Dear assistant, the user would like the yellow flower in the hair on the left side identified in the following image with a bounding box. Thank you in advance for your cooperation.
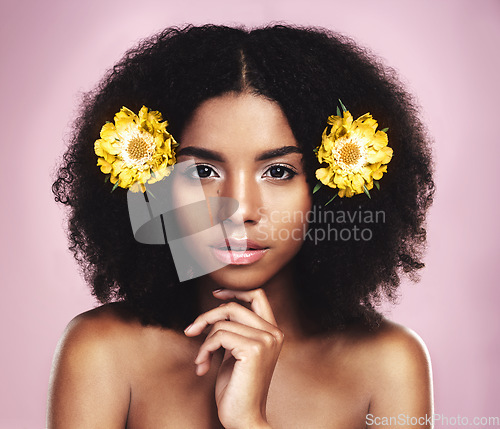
[94,106,178,192]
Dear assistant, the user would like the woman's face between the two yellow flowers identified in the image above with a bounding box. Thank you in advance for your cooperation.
[172,93,312,289]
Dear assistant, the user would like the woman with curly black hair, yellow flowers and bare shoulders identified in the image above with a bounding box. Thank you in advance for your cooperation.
[48,26,433,429]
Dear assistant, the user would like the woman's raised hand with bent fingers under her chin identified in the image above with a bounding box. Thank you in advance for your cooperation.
[185,289,283,429]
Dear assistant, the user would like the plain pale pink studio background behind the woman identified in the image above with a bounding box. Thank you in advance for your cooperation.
[0,0,500,429]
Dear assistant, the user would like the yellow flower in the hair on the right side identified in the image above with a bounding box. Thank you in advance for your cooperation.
[316,111,392,197]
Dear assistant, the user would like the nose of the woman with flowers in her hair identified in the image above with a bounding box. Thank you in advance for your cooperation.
[217,171,262,225]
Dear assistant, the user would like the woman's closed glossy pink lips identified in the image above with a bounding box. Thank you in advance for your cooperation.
[211,238,269,265]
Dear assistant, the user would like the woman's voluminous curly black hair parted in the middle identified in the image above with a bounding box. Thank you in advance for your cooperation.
[53,25,434,330]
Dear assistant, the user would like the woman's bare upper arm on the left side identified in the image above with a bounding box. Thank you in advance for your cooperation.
[47,314,130,429]
